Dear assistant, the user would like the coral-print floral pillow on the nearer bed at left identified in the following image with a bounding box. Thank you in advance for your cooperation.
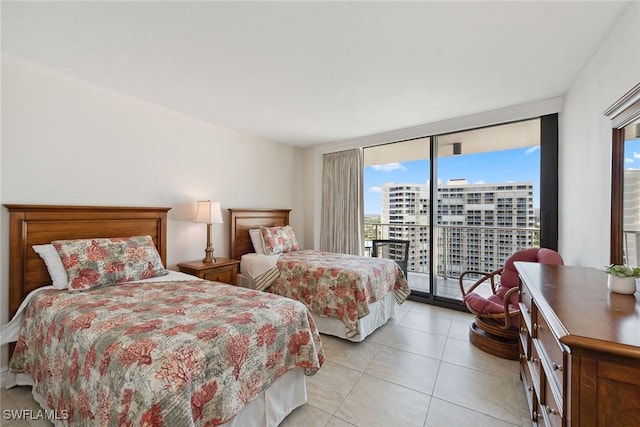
[51,236,169,292]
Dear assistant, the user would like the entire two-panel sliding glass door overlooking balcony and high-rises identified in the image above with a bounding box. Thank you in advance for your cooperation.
[364,116,557,307]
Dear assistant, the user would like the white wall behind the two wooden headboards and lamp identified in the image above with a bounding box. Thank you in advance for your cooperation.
[0,55,305,372]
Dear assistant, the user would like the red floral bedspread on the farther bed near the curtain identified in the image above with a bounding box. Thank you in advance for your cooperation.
[269,250,411,338]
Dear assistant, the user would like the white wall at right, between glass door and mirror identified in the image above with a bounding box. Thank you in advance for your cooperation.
[558,2,640,268]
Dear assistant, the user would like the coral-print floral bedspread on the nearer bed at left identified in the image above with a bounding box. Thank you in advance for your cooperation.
[10,280,324,426]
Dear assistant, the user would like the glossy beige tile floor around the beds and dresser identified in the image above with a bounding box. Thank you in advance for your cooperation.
[0,301,531,427]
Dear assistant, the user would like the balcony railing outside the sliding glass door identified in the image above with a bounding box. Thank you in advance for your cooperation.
[365,223,540,299]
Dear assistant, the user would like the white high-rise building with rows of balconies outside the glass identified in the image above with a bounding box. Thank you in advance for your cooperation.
[381,179,537,277]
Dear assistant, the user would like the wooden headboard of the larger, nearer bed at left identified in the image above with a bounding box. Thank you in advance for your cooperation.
[4,205,171,317]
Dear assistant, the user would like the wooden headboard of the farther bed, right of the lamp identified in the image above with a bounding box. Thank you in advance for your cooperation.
[229,209,291,259]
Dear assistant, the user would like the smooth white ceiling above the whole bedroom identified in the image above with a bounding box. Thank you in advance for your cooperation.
[1,1,630,146]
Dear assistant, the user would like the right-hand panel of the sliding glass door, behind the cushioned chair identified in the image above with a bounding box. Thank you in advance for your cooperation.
[433,119,540,300]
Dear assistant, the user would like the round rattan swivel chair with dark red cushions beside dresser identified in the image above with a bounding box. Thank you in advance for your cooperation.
[459,248,563,360]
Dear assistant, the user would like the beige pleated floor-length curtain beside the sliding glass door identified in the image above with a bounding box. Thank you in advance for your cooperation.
[320,148,364,255]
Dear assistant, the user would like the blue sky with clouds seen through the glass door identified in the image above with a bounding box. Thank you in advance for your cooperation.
[364,146,540,214]
